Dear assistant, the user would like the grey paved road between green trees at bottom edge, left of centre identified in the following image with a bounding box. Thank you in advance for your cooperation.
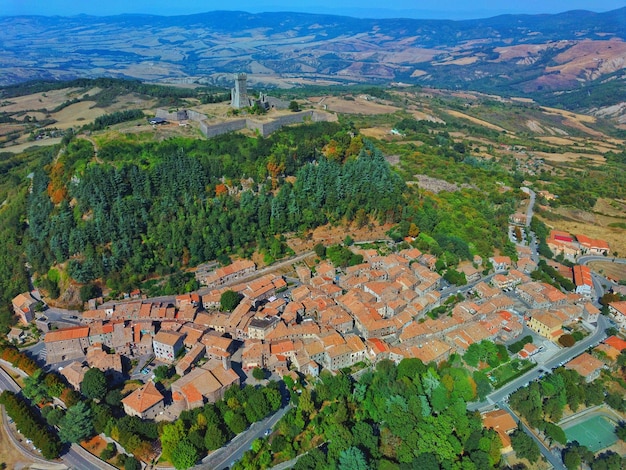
[194,405,291,470]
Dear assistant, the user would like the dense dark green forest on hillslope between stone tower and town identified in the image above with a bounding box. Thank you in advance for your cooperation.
[27,124,404,290]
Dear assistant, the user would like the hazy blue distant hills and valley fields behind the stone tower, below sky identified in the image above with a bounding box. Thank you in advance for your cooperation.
[0,8,626,94]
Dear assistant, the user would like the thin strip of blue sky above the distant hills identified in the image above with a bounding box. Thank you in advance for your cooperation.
[0,0,626,19]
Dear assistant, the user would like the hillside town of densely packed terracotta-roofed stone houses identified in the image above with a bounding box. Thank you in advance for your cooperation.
[9,217,626,430]
